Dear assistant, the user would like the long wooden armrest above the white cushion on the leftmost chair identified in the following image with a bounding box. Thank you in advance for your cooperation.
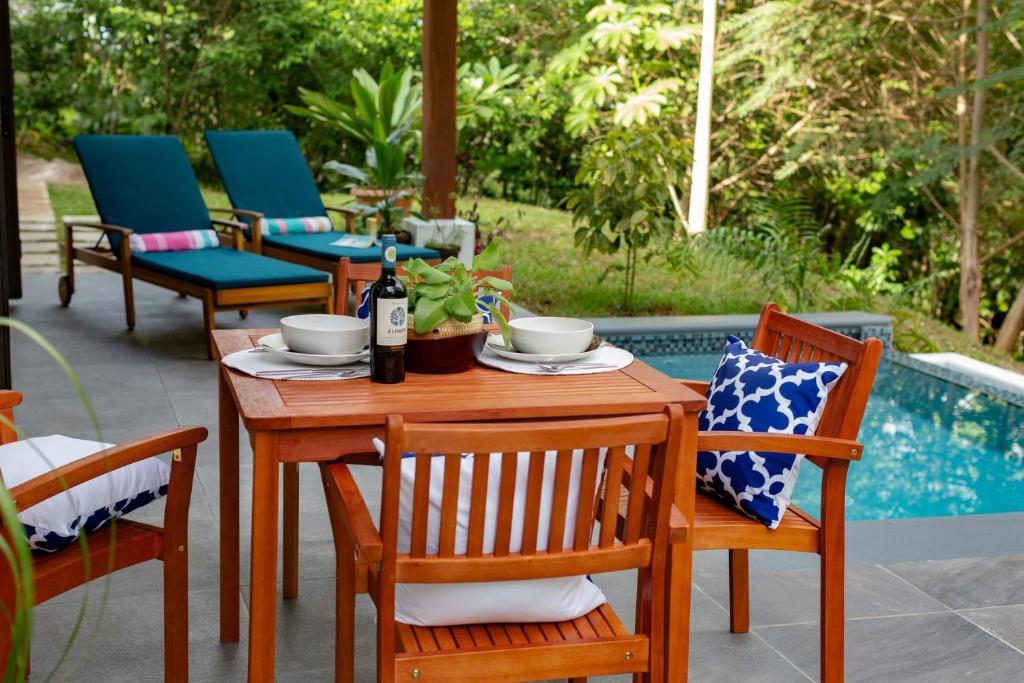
[10,427,207,510]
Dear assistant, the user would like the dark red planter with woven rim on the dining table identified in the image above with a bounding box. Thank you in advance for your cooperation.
[406,314,487,375]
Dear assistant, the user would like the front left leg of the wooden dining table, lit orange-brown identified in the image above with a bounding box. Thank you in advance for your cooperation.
[249,432,280,682]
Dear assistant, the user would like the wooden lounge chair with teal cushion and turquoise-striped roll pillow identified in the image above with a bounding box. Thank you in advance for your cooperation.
[204,130,440,286]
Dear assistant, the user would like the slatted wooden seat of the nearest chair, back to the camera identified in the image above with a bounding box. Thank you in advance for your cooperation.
[395,604,649,681]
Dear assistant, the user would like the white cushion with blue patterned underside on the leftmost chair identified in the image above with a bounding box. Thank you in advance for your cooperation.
[0,434,171,553]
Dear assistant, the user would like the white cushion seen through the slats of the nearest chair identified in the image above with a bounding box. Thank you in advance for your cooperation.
[374,439,607,626]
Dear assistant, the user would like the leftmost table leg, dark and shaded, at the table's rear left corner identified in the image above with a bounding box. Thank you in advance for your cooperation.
[217,370,240,643]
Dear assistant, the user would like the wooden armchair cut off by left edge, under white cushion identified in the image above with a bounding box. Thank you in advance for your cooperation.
[0,391,207,681]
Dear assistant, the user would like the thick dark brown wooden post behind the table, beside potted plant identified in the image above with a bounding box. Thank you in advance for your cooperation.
[423,0,459,218]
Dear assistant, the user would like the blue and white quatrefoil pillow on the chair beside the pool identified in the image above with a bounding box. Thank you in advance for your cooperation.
[697,337,847,528]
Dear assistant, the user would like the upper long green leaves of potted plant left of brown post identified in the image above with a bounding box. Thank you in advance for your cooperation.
[286,61,423,151]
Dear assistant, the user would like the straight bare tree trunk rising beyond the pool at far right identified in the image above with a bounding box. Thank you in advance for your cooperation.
[959,0,988,339]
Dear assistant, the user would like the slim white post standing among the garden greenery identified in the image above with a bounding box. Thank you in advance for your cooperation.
[687,0,716,234]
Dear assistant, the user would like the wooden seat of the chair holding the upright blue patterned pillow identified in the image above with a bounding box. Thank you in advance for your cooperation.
[693,493,820,553]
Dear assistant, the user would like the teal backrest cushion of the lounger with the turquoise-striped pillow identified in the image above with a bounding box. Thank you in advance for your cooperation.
[204,130,327,218]
